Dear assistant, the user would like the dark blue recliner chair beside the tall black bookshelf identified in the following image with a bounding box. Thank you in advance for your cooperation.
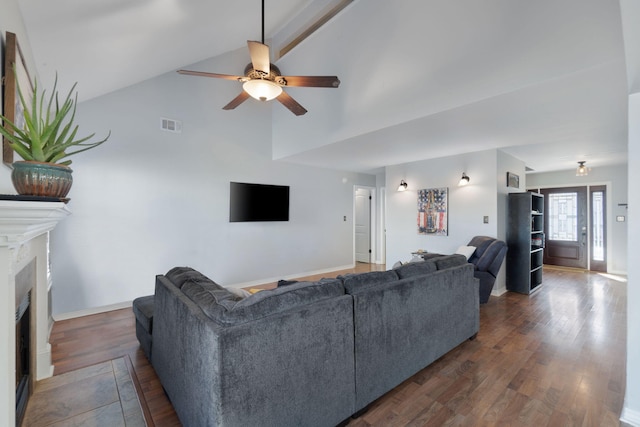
[468,236,507,304]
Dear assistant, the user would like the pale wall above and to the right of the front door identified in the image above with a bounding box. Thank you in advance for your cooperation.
[527,162,628,274]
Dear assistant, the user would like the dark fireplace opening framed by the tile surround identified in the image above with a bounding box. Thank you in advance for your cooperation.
[16,291,31,426]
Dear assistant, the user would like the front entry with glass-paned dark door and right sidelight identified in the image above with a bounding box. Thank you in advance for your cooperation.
[540,185,607,271]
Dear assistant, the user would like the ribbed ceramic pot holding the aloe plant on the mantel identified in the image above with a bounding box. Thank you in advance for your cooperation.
[11,161,73,198]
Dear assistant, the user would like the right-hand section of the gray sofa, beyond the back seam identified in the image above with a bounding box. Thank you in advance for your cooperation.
[344,255,480,411]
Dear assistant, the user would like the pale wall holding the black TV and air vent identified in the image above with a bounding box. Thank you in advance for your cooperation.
[46,49,375,314]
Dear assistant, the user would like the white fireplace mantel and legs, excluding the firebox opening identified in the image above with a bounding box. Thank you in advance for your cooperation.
[0,200,71,426]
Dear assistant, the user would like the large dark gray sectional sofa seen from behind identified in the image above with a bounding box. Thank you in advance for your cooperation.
[134,255,479,427]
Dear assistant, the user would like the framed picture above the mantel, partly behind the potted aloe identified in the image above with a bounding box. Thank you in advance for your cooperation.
[2,31,33,166]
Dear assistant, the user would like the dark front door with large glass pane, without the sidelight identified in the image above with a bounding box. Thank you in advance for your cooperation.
[541,187,589,269]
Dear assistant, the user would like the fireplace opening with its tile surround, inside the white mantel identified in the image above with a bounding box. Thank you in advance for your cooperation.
[16,259,36,426]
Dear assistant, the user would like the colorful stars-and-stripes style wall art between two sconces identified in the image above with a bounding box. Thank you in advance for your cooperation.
[418,188,449,236]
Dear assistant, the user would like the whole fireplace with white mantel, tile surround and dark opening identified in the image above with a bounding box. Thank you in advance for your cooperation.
[0,198,71,427]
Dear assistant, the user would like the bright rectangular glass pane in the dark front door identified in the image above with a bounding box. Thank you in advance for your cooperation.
[547,193,578,242]
